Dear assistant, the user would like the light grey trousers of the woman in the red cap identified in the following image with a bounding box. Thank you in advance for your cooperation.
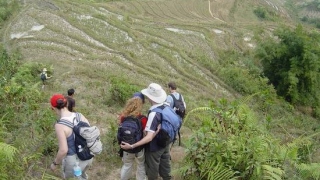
[61,154,93,179]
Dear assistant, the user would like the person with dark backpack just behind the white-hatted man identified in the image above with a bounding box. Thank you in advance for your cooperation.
[166,82,187,119]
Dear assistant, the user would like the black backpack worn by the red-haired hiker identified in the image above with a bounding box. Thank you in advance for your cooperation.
[117,116,143,153]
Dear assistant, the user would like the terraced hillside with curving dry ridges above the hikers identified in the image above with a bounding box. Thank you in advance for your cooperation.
[5,0,282,104]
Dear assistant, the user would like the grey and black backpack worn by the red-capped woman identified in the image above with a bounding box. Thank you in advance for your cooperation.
[57,113,102,161]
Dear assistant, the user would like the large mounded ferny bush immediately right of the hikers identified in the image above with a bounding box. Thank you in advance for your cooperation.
[181,100,284,180]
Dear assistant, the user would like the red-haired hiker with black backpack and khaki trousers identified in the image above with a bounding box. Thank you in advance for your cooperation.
[117,92,147,180]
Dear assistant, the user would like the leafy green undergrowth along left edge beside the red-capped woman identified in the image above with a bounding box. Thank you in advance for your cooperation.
[0,48,50,179]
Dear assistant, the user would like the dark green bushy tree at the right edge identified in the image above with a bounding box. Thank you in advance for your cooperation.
[257,25,320,106]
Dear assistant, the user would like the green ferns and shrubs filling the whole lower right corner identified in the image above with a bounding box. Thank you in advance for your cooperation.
[180,97,320,180]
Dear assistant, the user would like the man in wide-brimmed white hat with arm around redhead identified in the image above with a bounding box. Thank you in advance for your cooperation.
[120,83,171,180]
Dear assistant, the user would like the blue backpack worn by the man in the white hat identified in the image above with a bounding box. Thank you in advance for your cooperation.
[151,105,182,147]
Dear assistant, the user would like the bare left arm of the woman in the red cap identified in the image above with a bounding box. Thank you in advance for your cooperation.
[51,124,68,170]
